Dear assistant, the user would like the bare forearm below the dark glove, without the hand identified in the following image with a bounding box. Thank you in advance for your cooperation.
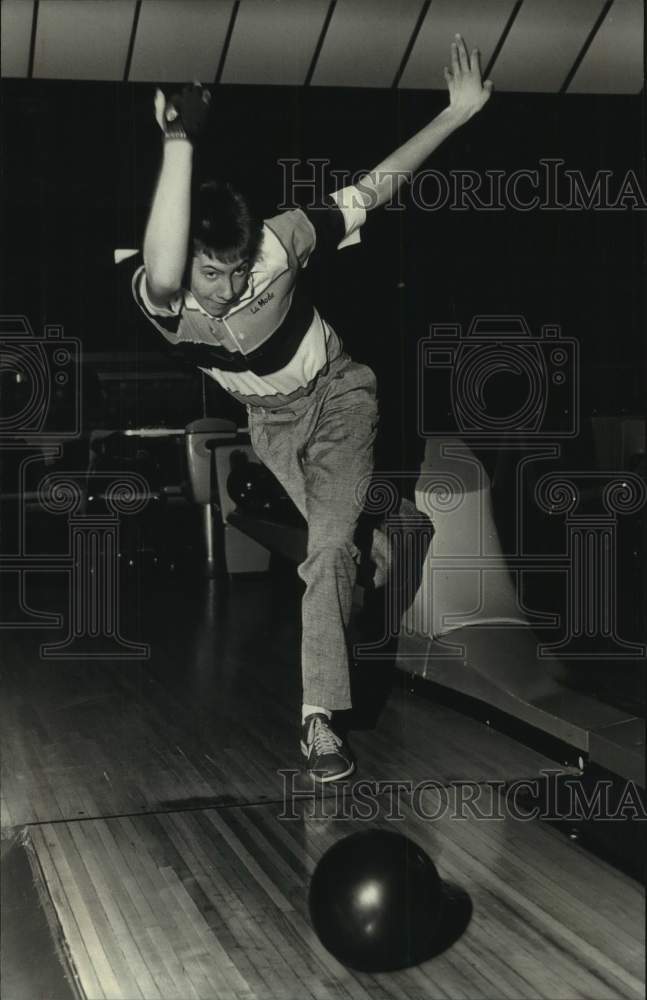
[144,139,193,305]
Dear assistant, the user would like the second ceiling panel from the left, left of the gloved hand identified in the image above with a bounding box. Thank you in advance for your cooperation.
[34,0,135,80]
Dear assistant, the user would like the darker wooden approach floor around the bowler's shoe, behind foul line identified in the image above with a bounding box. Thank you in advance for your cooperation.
[0,579,568,830]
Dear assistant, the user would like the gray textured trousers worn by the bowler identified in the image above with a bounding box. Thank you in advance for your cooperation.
[248,354,387,710]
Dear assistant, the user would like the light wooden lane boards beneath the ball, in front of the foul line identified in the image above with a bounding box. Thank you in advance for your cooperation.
[30,792,644,1000]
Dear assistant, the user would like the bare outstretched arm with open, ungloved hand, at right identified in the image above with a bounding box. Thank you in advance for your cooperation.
[356,35,493,209]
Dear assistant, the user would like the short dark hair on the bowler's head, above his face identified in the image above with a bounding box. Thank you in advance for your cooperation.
[191,181,263,263]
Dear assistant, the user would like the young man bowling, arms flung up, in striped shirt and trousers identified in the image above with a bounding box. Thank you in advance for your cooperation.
[133,35,492,781]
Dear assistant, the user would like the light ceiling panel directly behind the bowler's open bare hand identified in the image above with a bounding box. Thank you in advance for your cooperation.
[400,0,514,90]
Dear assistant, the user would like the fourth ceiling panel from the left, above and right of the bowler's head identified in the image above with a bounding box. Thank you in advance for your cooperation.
[222,0,329,86]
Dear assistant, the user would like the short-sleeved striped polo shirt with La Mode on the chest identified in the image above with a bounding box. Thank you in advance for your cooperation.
[132,187,366,409]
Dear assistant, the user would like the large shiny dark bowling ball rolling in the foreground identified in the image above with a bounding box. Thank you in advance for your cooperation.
[308,829,471,972]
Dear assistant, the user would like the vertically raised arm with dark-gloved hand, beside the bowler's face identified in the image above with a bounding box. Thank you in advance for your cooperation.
[143,85,209,305]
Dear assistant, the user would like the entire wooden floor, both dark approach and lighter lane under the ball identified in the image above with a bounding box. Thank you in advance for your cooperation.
[5,579,644,1000]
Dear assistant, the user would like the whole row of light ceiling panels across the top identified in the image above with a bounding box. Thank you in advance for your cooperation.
[0,0,644,94]
